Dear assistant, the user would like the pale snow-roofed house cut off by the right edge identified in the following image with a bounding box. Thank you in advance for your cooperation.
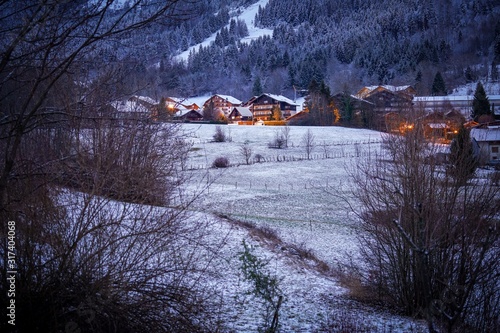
[470,121,500,165]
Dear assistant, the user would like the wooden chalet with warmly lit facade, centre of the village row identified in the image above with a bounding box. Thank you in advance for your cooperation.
[247,93,298,120]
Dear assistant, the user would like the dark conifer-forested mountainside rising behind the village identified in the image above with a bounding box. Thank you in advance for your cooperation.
[99,0,500,99]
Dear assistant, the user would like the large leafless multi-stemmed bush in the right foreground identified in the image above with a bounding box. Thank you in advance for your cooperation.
[352,122,500,332]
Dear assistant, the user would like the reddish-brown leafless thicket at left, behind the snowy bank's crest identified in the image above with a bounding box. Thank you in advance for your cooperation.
[58,121,189,205]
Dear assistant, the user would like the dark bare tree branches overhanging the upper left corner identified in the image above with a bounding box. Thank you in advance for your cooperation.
[0,0,191,207]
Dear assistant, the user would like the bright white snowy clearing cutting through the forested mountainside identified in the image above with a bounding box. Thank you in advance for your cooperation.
[176,0,273,61]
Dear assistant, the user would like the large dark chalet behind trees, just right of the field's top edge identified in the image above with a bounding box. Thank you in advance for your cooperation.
[355,85,416,131]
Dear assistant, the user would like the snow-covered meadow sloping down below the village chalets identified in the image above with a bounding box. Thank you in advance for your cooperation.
[178,124,424,332]
